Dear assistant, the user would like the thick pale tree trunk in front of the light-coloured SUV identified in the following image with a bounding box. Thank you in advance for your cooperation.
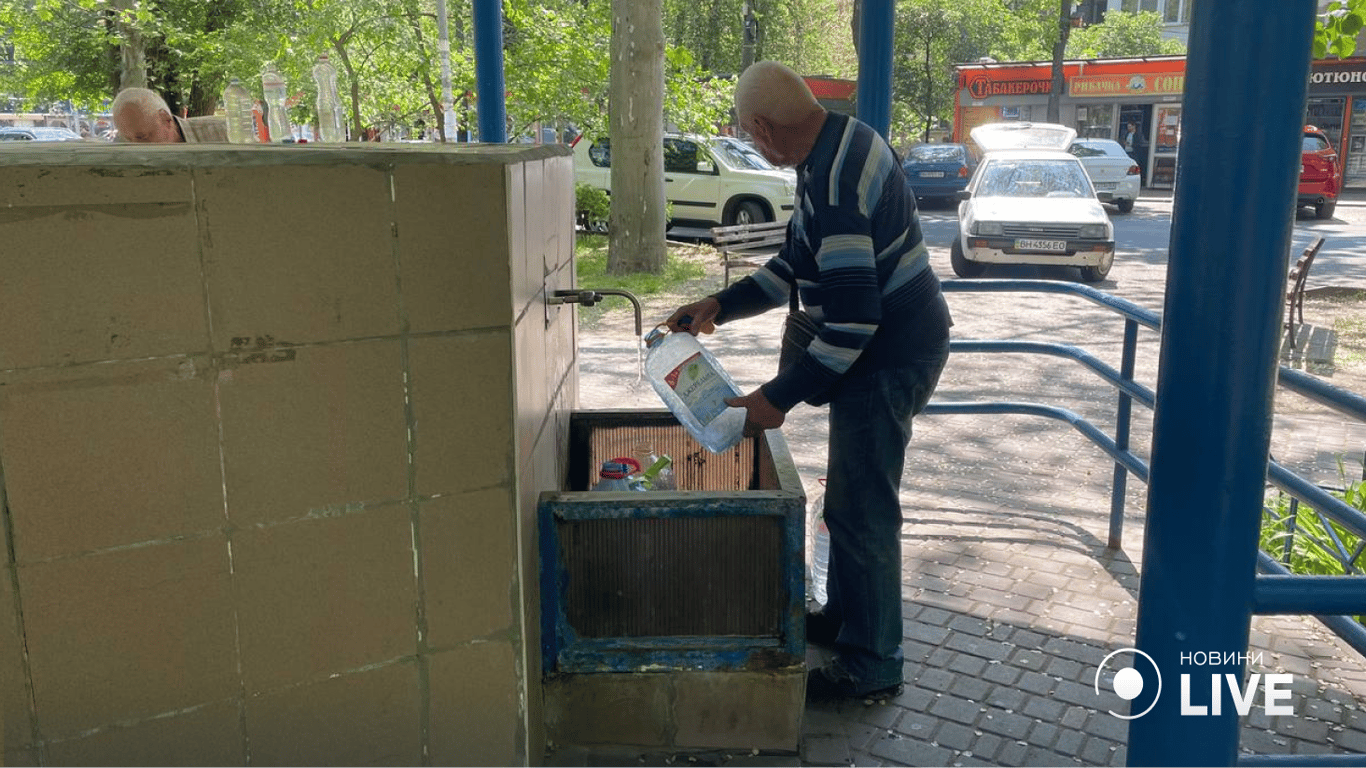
[607,0,665,275]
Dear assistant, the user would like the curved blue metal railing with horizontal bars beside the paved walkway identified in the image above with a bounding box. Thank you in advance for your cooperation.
[925,280,1366,767]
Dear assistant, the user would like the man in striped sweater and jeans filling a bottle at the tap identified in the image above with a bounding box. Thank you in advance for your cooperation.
[668,61,952,701]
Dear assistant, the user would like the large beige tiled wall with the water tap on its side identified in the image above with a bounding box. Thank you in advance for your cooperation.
[0,146,576,765]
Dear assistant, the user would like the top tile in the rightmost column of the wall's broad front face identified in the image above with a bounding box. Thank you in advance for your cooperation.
[393,164,512,333]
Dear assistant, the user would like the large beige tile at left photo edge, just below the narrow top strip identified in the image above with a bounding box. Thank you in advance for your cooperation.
[0,194,208,369]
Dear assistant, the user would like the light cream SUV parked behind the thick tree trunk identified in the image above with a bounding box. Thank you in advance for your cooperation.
[574,134,796,227]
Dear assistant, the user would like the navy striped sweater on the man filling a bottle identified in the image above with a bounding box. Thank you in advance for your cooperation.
[716,112,952,411]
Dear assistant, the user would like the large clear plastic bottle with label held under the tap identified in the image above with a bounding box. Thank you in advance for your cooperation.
[645,328,746,454]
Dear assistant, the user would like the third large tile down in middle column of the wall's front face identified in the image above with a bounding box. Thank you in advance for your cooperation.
[232,504,417,694]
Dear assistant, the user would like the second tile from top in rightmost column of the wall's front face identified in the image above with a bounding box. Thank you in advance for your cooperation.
[408,329,515,495]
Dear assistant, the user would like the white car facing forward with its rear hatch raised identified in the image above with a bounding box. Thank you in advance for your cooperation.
[949,123,1115,283]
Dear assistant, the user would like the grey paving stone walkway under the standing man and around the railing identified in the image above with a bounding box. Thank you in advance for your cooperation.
[556,217,1366,768]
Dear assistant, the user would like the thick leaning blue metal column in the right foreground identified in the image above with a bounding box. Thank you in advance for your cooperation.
[1128,0,1314,767]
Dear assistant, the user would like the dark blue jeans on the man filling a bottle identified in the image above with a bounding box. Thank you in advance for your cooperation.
[824,340,948,690]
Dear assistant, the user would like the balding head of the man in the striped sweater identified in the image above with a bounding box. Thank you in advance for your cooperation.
[735,61,825,165]
